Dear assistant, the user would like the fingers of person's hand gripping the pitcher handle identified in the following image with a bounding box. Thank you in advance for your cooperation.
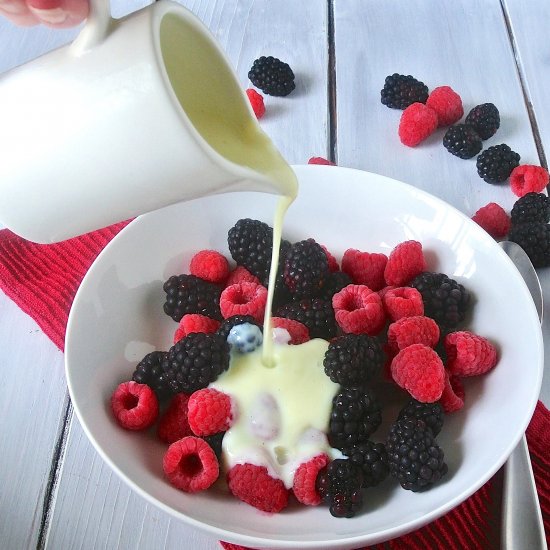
[0,0,89,28]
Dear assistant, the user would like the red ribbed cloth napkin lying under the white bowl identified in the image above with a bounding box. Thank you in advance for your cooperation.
[0,226,550,550]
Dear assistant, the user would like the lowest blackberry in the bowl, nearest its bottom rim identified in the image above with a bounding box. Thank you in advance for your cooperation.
[316,458,363,518]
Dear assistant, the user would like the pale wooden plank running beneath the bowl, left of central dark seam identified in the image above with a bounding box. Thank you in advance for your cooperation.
[47,0,327,550]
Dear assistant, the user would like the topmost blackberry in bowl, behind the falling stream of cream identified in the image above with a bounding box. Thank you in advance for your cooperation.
[227,218,290,286]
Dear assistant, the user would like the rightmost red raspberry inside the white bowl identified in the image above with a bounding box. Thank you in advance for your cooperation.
[444,330,498,376]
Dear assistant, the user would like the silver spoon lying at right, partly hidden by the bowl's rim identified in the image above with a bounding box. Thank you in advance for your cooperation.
[499,241,547,550]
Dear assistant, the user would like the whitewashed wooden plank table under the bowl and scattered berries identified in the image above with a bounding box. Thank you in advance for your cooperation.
[0,0,550,550]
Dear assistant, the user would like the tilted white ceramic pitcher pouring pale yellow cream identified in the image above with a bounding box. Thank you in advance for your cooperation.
[0,0,296,243]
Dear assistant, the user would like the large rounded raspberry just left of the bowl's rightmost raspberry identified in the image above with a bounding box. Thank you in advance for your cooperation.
[390,344,445,403]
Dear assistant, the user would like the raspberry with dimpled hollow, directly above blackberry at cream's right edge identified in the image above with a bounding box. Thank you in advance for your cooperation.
[332,285,386,336]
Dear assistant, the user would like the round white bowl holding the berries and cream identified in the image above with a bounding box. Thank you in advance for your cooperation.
[66,166,543,549]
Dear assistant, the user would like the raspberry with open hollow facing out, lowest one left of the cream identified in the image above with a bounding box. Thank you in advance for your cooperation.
[162,436,220,493]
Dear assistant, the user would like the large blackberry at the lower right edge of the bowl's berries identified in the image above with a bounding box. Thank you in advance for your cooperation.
[386,418,447,492]
